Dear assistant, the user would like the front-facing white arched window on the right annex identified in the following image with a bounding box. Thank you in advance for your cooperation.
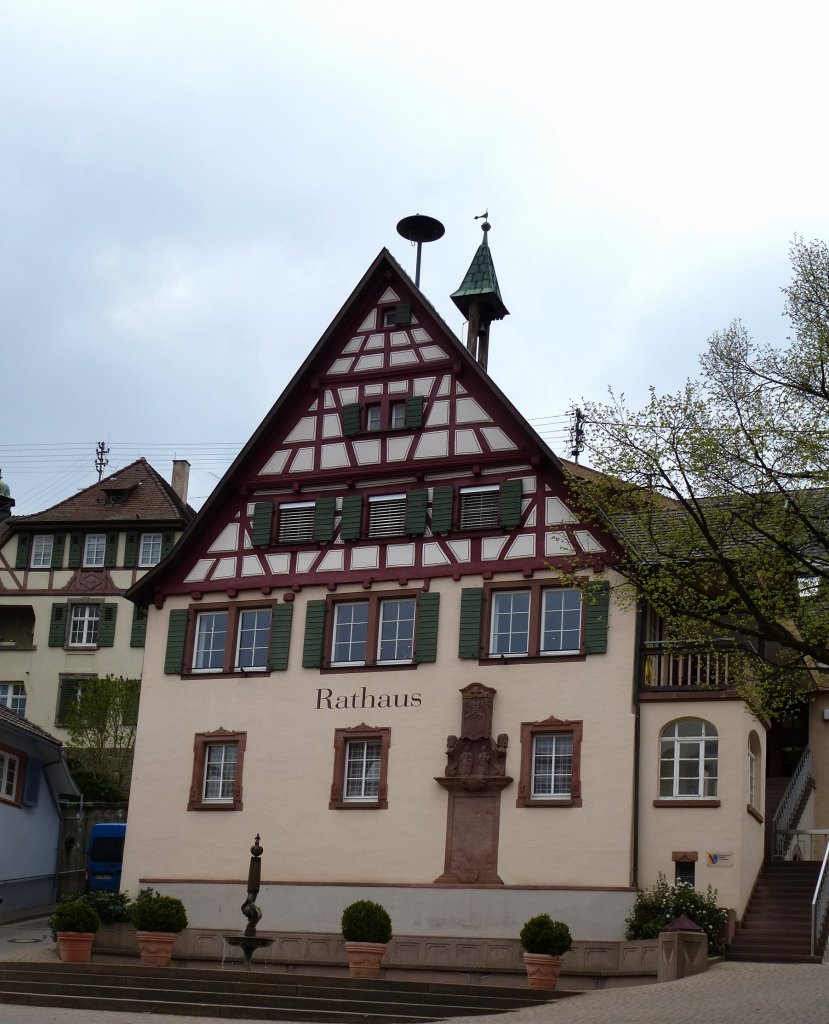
[659,718,717,800]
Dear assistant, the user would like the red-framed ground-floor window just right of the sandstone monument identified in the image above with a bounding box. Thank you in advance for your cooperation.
[516,718,582,807]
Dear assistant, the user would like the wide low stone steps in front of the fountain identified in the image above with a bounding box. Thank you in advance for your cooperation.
[0,962,576,1024]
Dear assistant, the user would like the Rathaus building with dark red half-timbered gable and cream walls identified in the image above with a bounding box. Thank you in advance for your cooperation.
[124,239,766,966]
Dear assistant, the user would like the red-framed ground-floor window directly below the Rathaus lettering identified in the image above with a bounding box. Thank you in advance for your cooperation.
[329,726,391,810]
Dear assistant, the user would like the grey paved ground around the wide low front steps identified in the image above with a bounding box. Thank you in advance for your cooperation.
[0,919,829,1024]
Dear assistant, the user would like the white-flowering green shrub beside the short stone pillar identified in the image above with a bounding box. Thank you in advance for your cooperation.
[624,872,728,956]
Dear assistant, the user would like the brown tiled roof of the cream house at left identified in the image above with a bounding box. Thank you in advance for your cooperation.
[4,459,195,530]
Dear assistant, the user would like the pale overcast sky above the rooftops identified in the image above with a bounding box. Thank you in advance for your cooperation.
[0,0,829,514]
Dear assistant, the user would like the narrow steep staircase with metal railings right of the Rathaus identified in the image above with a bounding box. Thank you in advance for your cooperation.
[726,860,826,964]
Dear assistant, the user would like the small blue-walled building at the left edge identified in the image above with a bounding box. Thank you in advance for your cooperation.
[0,706,78,920]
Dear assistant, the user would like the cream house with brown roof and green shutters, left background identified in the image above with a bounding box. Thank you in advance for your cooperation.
[0,459,194,739]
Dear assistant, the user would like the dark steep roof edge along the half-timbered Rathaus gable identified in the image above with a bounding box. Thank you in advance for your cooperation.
[127,249,562,604]
